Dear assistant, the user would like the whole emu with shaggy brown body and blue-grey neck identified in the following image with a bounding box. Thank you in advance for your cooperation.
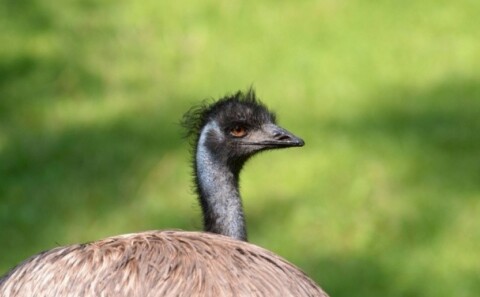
[0,88,328,297]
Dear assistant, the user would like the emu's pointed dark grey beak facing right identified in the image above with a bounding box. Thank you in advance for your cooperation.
[245,124,305,149]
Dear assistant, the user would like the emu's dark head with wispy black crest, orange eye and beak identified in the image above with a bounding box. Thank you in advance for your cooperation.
[183,89,304,171]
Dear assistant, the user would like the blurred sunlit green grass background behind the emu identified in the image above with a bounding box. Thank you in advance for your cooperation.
[0,0,480,297]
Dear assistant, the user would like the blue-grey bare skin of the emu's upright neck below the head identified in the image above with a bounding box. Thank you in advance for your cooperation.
[195,122,247,241]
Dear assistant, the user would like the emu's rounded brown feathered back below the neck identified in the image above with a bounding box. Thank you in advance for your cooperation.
[0,231,326,297]
